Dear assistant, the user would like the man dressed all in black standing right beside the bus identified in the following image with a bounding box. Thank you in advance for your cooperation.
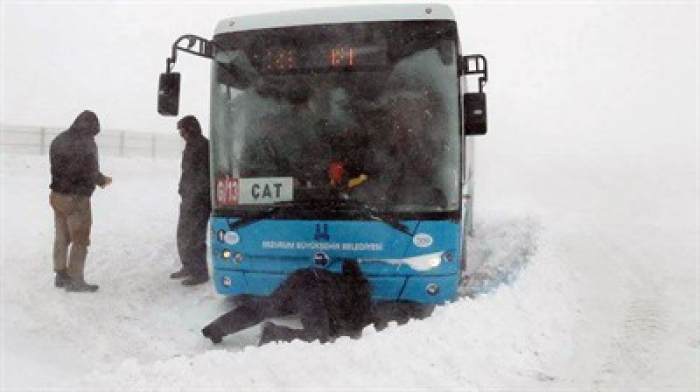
[170,116,211,286]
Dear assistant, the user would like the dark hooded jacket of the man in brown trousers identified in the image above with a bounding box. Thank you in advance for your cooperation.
[49,111,105,196]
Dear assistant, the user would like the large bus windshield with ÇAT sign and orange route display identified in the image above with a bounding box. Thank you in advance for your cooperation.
[211,21,460,214]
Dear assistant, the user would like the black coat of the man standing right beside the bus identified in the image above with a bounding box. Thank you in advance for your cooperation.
[178,135,211,203]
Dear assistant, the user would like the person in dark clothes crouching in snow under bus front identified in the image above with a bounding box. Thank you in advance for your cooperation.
[202,260,372,345]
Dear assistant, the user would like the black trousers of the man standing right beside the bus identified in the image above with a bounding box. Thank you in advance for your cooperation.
[177,198,211,275]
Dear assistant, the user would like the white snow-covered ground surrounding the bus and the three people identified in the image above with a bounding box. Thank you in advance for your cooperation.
[2,140,700,389]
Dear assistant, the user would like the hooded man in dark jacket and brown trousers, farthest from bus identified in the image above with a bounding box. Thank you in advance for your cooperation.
[49,110,112,292]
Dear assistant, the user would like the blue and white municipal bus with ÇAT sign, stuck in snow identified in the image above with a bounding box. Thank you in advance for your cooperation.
[158,4,487,305]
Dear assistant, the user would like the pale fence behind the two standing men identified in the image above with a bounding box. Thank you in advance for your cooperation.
[0,125,184,158]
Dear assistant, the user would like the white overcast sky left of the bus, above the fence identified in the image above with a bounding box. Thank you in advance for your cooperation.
[2,0,492,132]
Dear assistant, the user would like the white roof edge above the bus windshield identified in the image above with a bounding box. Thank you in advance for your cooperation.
[214,4,455,35]
